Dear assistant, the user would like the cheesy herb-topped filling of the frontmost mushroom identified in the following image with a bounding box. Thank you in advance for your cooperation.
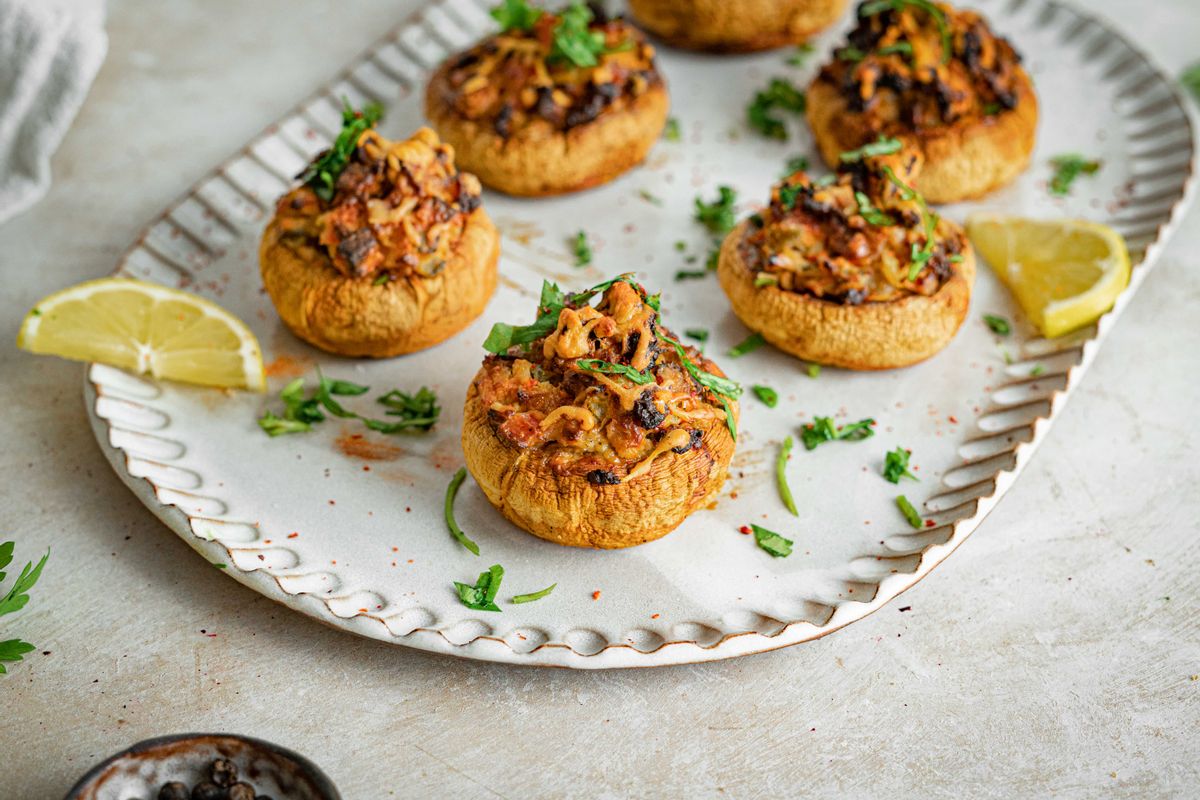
[475,277,740,485]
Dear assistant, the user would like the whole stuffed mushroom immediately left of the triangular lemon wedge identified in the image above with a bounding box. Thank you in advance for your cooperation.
[718,139,974,369]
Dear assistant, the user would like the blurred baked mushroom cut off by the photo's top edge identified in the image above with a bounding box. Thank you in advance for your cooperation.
[629,0,846,52]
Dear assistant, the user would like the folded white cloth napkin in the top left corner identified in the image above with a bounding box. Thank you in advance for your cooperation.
[0,0,108,223]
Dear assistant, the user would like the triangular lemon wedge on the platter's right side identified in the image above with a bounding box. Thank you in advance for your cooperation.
[967,213,1129,337]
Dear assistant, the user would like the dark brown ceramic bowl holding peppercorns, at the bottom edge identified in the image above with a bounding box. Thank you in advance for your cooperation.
[66,733,342,800]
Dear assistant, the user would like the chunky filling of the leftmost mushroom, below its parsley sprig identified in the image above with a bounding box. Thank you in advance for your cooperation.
[276,128,480,283]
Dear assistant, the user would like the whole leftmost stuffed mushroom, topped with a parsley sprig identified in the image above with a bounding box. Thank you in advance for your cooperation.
[259,108,500,357]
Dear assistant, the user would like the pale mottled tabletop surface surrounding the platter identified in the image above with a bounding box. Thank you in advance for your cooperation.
[0,0,1200,799]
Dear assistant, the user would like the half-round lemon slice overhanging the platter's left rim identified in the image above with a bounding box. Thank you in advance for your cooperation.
[17,278,266,391]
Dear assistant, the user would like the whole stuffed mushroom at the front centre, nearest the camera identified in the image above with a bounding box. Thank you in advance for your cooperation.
[462,275,742,548]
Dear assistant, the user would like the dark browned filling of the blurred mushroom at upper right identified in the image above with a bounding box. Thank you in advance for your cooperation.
[820,0,1021,133]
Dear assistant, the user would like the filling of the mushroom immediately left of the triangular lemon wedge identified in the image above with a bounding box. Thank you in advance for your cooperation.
[739,148,966,305]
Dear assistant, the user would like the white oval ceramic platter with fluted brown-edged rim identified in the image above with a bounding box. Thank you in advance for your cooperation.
[86,0,1193,668]
